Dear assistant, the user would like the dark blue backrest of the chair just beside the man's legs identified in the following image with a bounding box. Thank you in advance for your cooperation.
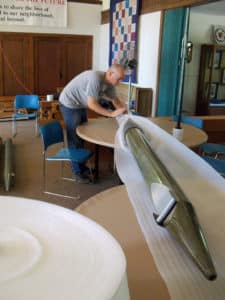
[40,121,64,150]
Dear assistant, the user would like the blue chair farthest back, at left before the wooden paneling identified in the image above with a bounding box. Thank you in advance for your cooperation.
[12,95,40,137]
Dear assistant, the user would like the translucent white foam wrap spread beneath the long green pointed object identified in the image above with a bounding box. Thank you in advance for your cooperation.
[115,116,225,300]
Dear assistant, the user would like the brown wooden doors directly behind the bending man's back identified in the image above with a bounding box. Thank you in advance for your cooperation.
[34,35,92,95]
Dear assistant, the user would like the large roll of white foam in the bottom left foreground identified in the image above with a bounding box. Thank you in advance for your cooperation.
[0,196,129,300]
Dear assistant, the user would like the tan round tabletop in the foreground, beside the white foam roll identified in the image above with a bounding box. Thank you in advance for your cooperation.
[76,185,170,300]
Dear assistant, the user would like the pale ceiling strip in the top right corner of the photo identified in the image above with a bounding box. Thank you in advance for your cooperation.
[191,0,225,16]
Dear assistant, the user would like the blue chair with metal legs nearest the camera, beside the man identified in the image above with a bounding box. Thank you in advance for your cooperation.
[40,121,93,199]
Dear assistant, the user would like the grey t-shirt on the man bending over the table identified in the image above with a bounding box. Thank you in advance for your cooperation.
[59,70,115,108]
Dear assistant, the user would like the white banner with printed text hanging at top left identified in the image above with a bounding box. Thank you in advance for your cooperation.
[0,0,67,27]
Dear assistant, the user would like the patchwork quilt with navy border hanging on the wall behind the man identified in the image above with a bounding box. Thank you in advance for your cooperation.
[109,0,139,83]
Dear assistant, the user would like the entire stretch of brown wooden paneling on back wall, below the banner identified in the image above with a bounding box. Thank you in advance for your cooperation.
[0,32,93,96]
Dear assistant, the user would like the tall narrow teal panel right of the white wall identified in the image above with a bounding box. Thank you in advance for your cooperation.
[157,8,186,116]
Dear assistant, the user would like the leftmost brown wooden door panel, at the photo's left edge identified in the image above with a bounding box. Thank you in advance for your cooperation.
[0,33,34,96]
